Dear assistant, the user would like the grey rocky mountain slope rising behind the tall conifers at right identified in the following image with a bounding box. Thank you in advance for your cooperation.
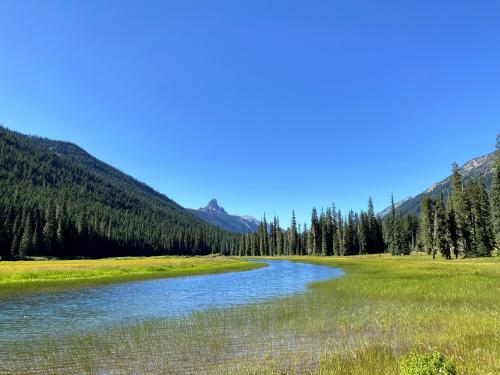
[380,152,495,218]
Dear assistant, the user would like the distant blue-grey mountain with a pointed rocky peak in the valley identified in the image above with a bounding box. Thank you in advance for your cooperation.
[190,199,260,233]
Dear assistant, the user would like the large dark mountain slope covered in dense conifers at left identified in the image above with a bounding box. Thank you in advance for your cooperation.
[0,127,239,259]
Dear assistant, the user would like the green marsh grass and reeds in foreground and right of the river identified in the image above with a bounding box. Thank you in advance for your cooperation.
[0,256,500,375]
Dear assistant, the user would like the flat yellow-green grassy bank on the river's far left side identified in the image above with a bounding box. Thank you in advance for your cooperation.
[0,256,264,297]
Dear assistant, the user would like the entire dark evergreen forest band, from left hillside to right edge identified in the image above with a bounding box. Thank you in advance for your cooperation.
[0,127,500,259]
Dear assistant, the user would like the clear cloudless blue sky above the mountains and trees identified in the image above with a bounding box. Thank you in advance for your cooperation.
[0,0,500,226]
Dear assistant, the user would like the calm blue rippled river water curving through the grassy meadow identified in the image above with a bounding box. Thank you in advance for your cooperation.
[0,260,343,345]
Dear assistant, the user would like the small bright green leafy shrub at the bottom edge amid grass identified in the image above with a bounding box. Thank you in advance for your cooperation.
[399,350,456,375]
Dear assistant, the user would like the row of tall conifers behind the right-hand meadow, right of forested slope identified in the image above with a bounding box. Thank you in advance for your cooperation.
[231,136,500,259]
